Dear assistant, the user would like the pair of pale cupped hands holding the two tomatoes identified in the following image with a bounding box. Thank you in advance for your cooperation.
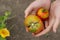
[25,0,60,37]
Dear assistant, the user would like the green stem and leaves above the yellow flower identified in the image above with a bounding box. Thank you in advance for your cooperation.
[0,11,11,29]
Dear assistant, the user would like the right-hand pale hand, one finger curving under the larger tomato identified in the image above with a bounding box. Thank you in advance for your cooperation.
[34,1,60,37]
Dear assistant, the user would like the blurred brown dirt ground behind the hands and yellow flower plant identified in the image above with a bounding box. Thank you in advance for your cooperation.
[0,0,60,40]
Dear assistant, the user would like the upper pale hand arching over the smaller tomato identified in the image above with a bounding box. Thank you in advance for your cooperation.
[25,0,50,17]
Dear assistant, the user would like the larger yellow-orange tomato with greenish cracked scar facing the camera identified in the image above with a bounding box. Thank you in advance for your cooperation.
[24,15,44,33]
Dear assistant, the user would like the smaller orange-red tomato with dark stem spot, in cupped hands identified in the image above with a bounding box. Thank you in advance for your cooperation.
[37,8,49,20]
